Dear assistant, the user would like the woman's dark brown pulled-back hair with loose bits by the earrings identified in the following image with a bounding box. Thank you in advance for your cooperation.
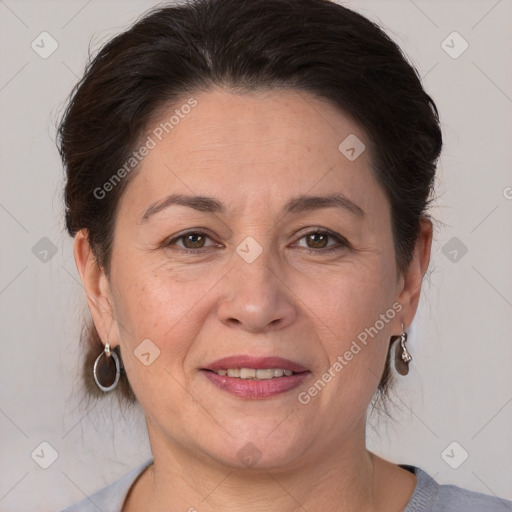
[58,0,442,408]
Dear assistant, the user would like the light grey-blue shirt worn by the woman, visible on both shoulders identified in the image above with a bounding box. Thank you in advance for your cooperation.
[61,460,512,512]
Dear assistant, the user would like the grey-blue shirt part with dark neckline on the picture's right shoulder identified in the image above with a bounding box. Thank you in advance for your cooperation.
[401,465,512,512]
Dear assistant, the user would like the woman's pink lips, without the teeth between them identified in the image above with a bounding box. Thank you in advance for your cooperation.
[201,355,311,399]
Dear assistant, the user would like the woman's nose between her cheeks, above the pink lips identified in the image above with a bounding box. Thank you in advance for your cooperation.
[217,246,298,333]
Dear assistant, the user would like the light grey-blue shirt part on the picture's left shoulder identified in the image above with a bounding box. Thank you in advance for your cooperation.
[61,459,153,512]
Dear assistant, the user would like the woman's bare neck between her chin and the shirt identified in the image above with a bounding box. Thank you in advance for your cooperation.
[134,422,382,512]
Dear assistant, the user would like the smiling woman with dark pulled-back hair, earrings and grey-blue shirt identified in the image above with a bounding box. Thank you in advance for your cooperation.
[59,0,511,512]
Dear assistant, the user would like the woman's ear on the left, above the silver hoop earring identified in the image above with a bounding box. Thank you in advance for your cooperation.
[73,229,119,348]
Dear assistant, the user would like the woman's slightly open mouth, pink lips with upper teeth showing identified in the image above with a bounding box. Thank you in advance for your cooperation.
[201,355,311,399]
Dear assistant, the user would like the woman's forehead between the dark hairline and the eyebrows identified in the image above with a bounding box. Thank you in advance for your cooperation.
[118,89,385,222]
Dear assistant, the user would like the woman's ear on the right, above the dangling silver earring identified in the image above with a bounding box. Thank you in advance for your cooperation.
[396,218,432,335]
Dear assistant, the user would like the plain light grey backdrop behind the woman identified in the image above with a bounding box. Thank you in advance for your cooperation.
[0,0,512,512]
